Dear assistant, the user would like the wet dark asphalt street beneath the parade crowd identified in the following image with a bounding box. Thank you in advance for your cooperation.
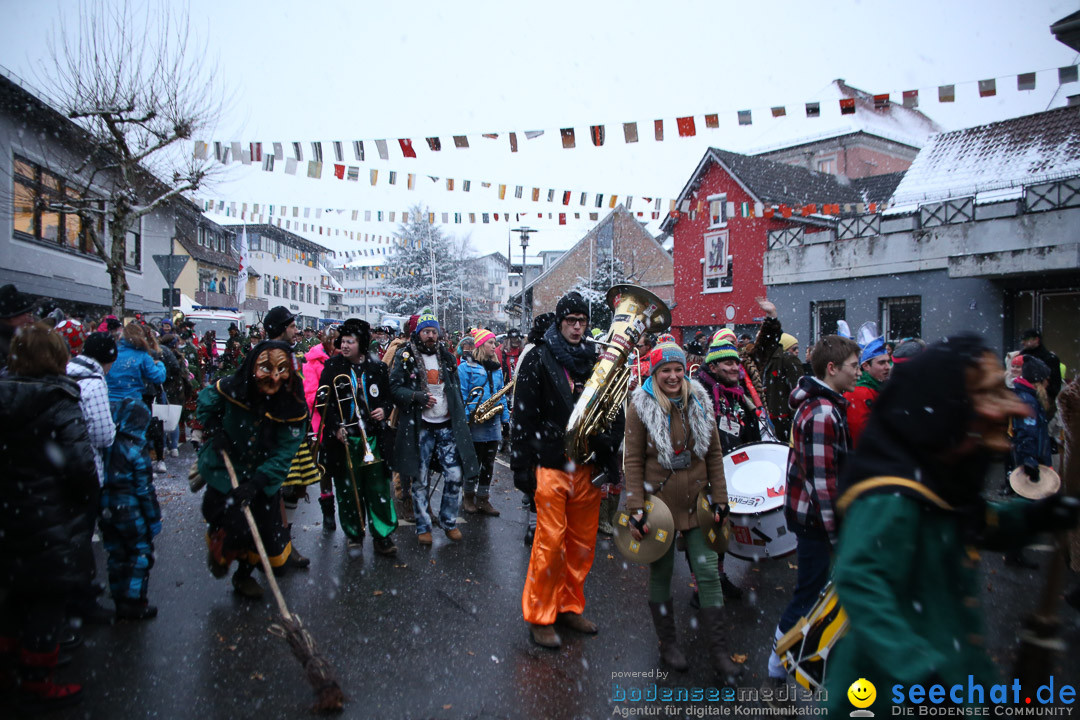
[38,446,1080,720]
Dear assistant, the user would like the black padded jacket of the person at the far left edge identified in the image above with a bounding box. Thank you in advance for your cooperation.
[0,377,98,597]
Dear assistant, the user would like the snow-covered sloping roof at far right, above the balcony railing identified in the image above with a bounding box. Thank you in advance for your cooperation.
[892,107,1080,206]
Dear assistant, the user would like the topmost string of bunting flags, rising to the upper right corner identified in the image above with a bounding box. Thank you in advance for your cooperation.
[193,65,1078,164]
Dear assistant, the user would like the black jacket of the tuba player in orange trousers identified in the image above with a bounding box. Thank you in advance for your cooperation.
[510,343,626,472]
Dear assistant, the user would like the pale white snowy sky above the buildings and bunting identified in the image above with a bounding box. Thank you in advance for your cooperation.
[0,0,1080,258]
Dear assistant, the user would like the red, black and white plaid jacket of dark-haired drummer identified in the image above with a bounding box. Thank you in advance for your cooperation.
[784,377,851,545]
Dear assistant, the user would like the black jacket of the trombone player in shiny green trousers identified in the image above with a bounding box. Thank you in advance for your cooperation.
[319,355,394,467]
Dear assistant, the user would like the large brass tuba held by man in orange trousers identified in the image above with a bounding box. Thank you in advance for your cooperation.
[566,285,672,464]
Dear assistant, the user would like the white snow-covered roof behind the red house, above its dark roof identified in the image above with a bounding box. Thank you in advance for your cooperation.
[750,79,942,154]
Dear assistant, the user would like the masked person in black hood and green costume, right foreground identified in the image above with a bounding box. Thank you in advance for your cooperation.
[825,335,1080,717]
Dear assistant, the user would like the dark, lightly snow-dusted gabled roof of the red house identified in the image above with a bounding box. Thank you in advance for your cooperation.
[660,148,866,232]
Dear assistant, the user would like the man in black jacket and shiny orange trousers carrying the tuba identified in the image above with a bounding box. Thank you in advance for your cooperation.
[510,293,623,649]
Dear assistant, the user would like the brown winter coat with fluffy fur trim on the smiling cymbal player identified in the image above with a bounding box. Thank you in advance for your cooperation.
[623,379,728,530]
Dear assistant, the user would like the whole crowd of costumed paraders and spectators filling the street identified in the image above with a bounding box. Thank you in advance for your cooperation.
[0,278,1080,711]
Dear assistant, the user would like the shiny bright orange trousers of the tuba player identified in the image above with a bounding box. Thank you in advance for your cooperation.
[522,465,600,625]
